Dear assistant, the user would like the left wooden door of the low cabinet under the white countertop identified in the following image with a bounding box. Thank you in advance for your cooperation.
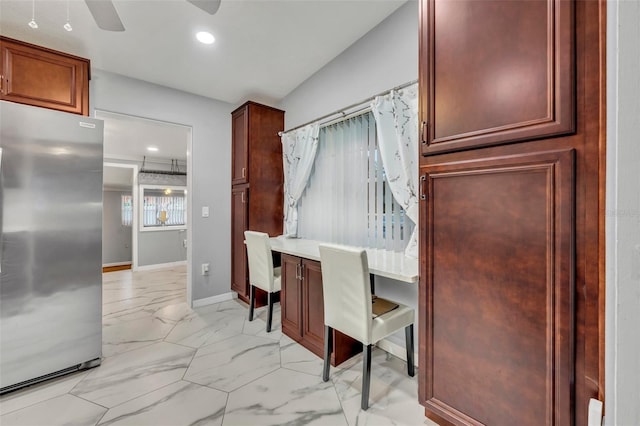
[280,254,302,341]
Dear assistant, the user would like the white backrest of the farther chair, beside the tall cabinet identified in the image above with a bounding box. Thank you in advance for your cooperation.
[244,231,274,293]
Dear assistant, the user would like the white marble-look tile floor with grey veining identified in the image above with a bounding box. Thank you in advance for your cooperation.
[0,267,435,426]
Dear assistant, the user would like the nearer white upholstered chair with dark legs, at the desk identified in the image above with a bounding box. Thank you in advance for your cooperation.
[320,244,415,410]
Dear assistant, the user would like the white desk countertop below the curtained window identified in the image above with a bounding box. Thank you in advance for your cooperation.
[270,236,418,283]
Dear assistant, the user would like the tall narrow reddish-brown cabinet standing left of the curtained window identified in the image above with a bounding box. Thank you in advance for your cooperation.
[231,102,284,306]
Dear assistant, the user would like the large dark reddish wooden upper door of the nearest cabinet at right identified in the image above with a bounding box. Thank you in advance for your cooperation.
[419,0,575,155]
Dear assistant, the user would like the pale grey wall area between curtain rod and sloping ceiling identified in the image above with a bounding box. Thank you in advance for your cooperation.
[279,0,418,129]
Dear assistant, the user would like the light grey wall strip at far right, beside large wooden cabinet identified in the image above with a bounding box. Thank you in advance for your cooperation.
[605,0,640,426]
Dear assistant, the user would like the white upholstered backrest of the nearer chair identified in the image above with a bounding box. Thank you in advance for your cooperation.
[320,244,371,344]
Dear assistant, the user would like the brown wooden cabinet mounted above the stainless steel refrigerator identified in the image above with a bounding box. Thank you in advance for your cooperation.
[0,37,90,115]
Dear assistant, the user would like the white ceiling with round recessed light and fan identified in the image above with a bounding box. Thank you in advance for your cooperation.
[0,0,406,104]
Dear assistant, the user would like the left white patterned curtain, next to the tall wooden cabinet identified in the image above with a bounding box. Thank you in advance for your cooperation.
[282,123,319,237]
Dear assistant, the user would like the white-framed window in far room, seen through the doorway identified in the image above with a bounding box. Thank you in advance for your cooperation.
[140,185,187,231]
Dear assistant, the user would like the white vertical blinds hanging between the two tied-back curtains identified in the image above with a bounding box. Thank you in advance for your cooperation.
[298,112,413,251]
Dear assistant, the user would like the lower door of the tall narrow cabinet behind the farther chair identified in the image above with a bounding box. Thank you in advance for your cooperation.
[231,185,249,299]
